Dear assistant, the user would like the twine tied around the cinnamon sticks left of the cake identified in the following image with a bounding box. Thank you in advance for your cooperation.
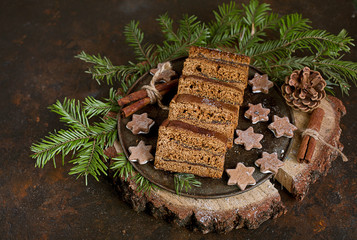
[142,62,172,110]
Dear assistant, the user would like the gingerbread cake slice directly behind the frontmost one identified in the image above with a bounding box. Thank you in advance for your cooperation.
[168,94,239,148]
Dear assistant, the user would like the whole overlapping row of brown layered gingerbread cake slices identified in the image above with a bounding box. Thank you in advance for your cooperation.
[155,46,250,178]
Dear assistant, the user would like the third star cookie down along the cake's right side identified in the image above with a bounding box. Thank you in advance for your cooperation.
[234,127,264,151]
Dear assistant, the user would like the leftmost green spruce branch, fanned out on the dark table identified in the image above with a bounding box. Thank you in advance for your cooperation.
[31,94,117,184]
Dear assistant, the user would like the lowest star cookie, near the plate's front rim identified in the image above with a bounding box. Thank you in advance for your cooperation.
[226,163,256,190]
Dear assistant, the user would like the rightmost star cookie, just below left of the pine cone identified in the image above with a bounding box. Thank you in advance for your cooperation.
[268,115,297,138]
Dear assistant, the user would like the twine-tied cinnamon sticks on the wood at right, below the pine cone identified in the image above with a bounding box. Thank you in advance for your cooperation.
[297,108,325,163]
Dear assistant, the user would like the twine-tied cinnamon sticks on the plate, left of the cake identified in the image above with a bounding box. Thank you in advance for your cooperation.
[118,79,178,118]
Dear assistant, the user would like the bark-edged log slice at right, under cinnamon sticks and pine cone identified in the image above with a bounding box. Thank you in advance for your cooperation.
[276,96,346,200]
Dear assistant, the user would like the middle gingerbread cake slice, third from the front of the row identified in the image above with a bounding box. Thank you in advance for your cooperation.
[177,75,244,106]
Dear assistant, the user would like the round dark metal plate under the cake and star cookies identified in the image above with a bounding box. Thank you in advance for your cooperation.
[118,58,294,198]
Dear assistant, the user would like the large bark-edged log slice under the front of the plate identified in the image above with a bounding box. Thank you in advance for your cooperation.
[106,142,285,233]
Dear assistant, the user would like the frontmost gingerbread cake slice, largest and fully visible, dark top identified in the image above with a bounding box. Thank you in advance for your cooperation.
[154,120,227,178]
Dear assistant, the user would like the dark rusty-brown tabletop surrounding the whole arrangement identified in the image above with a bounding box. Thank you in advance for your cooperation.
[0,0,357,240]
